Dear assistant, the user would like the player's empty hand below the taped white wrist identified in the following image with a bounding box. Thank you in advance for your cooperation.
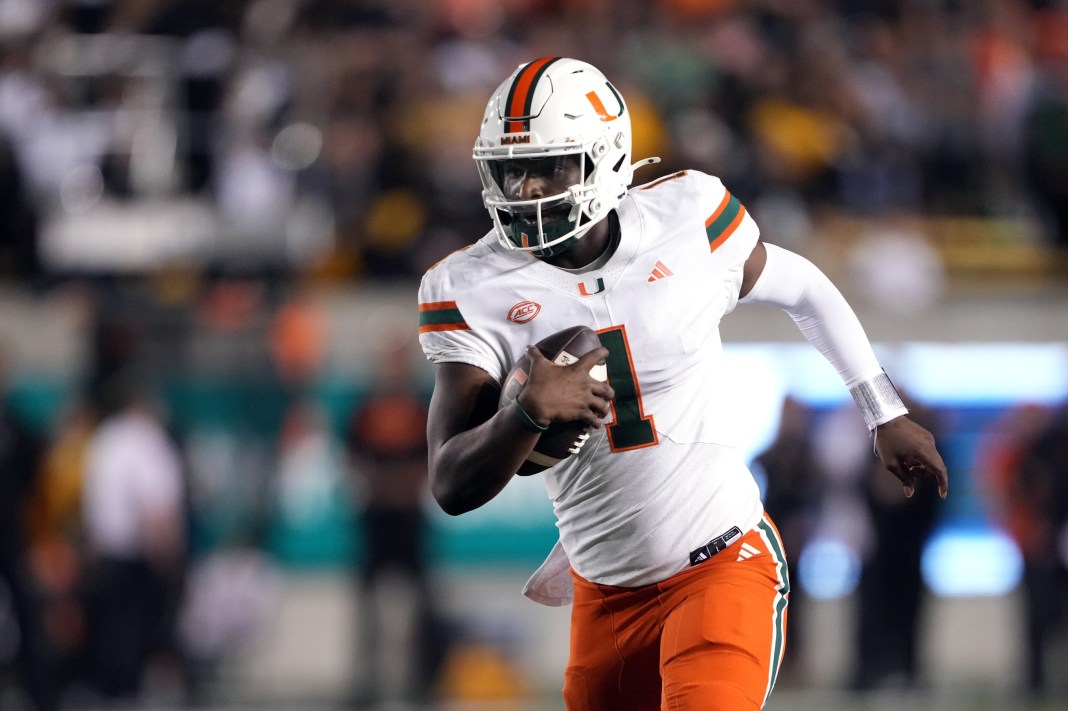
[875,415,949,499]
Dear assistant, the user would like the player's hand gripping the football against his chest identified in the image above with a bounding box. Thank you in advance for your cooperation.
[519,346,615,428]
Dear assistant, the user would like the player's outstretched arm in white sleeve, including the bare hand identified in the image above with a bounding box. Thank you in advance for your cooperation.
[739,241,949,499]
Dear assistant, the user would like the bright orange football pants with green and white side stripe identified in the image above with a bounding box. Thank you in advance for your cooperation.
[564,516,789,711]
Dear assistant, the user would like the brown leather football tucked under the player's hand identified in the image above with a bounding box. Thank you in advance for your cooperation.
[498,326,608,476]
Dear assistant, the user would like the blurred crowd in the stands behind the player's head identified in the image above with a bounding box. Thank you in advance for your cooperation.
[0,0,1068,286]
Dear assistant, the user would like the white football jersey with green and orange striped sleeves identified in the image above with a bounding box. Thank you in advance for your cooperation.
[419,171,763,597]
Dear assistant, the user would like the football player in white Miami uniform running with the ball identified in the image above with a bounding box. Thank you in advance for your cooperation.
[419,58,948,711]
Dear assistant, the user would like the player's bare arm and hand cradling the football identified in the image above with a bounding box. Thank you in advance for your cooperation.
[426,347,612,516]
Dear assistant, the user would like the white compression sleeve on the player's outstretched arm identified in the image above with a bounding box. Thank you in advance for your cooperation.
[739,243,908,428]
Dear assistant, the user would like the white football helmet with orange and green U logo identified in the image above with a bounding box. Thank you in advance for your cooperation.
[474,57,659,256]
